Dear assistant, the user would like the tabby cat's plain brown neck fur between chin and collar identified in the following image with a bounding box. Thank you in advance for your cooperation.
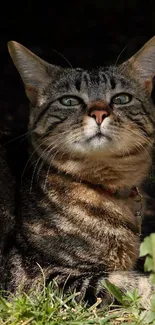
[35,144,151,191]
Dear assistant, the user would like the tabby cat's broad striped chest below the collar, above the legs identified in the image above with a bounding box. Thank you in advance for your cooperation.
[19,172,139,270]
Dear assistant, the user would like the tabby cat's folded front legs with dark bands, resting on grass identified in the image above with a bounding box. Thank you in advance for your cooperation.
[51,271,155,309]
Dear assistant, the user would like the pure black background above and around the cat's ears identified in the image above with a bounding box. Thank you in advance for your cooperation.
[0,0,155,127]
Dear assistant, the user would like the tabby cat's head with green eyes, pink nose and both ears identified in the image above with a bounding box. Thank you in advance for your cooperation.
[8,37,155,163]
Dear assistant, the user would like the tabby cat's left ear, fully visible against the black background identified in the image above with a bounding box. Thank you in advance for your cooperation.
[8,41,58,105]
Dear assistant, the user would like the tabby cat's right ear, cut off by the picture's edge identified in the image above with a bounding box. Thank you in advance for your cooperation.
[128,36,155,92]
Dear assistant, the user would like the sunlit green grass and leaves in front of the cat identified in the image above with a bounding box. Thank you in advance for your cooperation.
[0,234,155,325]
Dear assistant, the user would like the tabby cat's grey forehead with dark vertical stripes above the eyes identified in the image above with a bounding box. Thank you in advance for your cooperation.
[51,67,130,100]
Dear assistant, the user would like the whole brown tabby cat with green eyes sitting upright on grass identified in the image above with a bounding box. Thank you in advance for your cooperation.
[1,37,155,304]
